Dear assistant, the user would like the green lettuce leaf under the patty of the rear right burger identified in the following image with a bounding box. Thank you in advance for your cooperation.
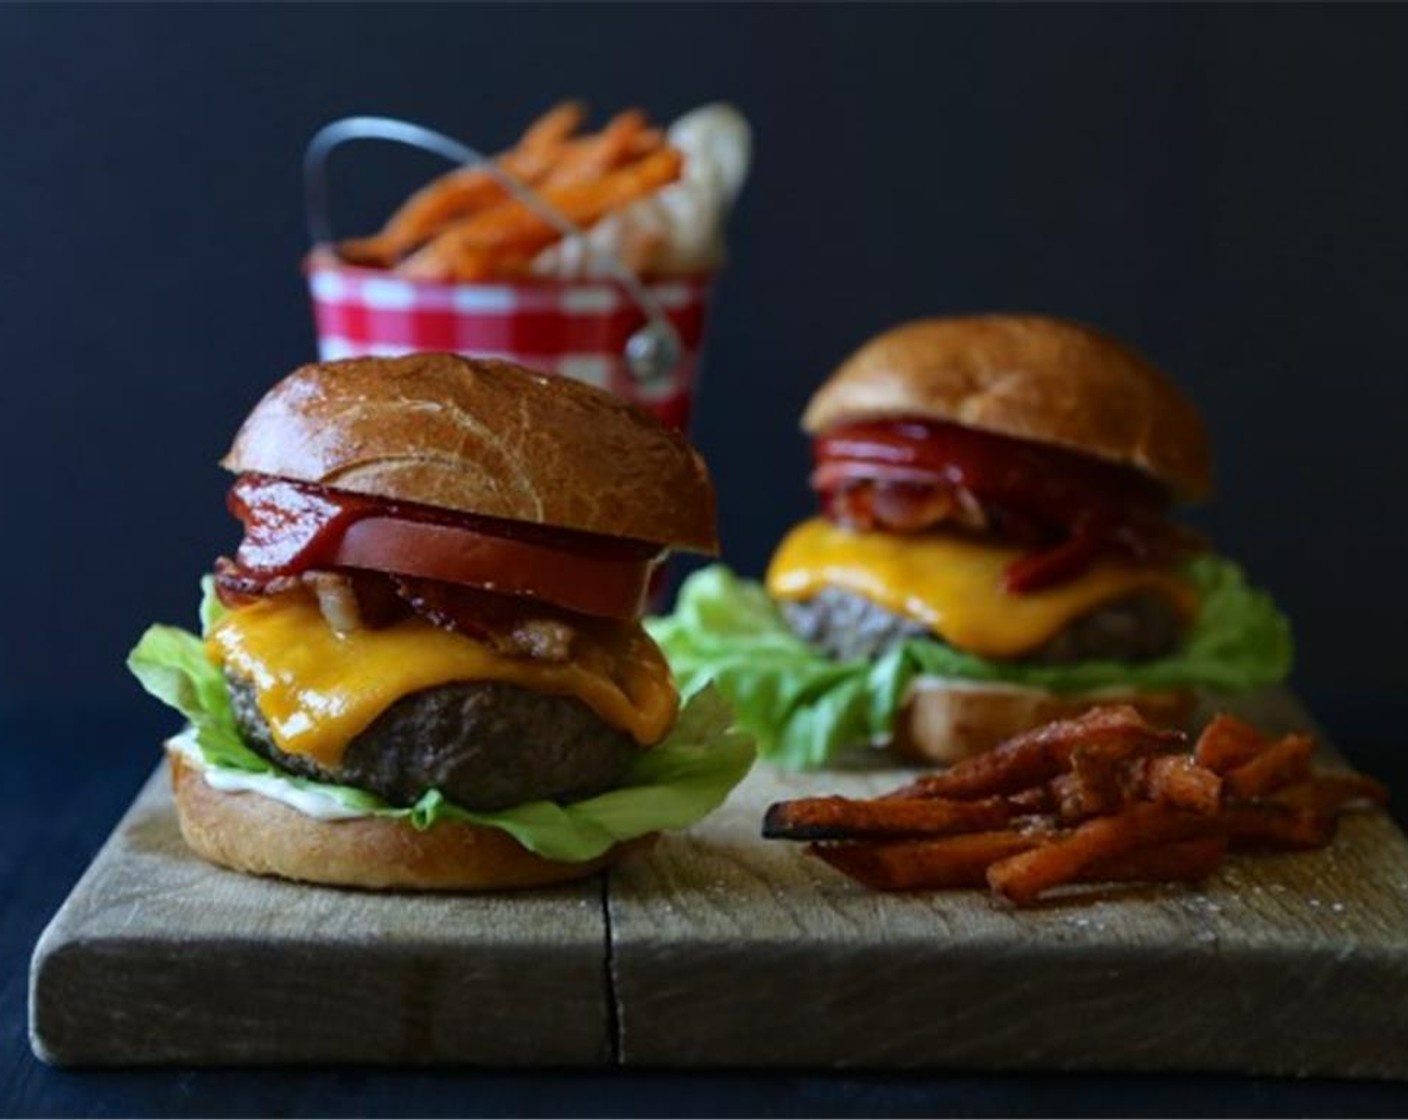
[646,555,1291,769]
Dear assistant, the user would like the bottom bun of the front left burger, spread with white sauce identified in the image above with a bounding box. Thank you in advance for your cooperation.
[166,749,655,890]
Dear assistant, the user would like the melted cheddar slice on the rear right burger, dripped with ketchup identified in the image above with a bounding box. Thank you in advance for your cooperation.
[767,518,1198,658]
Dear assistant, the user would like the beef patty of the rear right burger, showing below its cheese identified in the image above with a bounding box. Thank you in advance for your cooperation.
[779,587,1183,665]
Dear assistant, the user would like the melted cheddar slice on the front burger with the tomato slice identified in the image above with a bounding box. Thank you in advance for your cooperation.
[206,593,679,766]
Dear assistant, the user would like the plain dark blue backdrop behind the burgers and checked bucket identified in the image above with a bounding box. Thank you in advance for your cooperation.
[0,6,1408,718]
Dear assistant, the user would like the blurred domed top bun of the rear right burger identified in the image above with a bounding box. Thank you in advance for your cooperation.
[803,314,1212,499]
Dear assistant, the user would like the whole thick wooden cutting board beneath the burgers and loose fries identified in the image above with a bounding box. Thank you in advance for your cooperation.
[30,693,1408,1078]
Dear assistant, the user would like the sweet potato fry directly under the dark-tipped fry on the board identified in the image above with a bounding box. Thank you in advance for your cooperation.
[808,830,1041,890]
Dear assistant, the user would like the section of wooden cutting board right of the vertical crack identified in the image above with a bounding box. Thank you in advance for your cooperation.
[608,693,1408,1078]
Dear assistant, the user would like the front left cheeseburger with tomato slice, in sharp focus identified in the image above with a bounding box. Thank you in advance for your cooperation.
[130,354,750,889]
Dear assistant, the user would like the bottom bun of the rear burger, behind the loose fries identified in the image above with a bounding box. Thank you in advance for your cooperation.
[894,678,1198,764]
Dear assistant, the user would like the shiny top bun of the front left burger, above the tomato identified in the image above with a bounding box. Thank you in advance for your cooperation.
[221,354,718,554]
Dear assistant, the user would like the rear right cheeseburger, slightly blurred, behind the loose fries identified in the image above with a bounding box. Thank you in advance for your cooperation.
[659,316,1290,765]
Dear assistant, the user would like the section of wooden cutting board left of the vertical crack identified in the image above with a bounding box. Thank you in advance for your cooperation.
[30,764,610,1065]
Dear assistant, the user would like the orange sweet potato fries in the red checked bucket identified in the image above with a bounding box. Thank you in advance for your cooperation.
[338,101,683,280]
